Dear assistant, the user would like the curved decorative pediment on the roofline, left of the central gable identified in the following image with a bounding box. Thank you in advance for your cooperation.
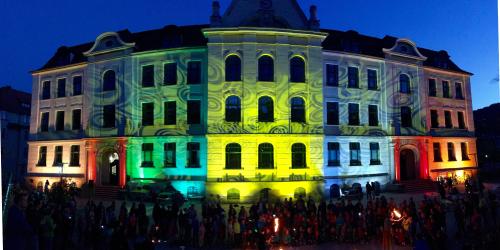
[83,32,135,56]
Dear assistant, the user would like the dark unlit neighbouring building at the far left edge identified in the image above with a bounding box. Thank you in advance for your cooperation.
[0,86,31,187]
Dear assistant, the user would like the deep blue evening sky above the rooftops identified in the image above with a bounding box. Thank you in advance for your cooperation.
[0,0,500,109]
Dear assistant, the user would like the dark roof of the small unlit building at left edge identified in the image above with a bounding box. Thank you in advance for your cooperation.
[0,86,31,115]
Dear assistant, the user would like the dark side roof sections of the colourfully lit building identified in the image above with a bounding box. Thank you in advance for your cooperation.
[39,25,471,75]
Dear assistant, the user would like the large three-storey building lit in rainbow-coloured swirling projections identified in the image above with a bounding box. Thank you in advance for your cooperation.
[28,0,477,200]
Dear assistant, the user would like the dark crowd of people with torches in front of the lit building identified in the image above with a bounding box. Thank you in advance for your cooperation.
[4,177,500,250]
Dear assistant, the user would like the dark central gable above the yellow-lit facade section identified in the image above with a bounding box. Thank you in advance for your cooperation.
[220,0,309,30]
